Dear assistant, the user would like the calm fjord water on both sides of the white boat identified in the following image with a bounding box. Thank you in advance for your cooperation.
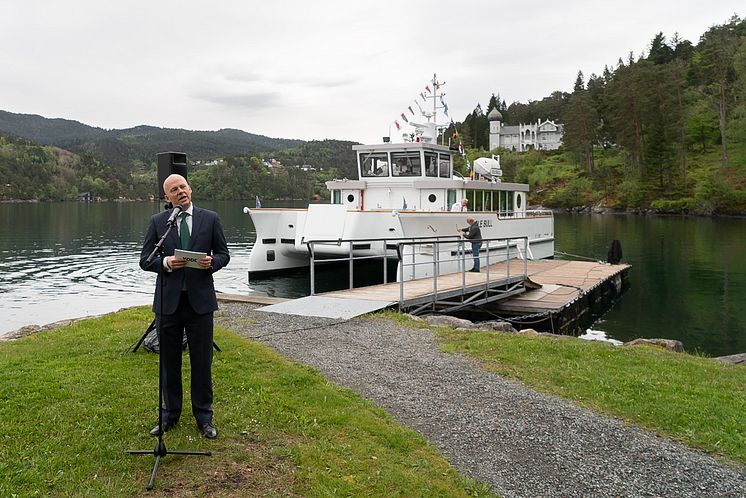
[0,200,746,356]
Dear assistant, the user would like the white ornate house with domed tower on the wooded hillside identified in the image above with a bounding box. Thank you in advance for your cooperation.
[487,109,565,151]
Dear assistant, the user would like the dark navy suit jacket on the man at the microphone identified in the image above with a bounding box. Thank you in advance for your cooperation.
[140,206,230,315]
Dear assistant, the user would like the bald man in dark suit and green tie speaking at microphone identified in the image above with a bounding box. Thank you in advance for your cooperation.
[140,175,230,439]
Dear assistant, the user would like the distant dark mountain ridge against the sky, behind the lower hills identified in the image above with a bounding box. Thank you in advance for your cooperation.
[0,111,306,165]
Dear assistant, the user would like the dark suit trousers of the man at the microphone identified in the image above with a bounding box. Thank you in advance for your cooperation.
[158,291,213,426]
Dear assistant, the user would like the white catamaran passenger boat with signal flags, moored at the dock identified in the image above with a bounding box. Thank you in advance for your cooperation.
[244,74,554,280]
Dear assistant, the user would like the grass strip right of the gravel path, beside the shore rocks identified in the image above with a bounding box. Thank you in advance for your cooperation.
[428,320,746,464]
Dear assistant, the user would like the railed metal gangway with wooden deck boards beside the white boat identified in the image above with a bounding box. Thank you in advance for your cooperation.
[305,235,531,314]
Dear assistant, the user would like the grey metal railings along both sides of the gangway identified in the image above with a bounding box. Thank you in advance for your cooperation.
[304,235,531,310]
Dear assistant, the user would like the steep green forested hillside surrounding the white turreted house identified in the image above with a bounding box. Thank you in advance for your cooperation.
[447,17,746,214]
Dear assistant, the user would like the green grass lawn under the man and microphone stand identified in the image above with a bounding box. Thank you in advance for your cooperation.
[0,308,492,497]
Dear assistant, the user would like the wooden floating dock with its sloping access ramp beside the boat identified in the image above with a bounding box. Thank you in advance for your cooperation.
[261,260,630,332]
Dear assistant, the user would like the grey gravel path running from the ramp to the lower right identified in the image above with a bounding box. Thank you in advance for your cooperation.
[216,303,746,497]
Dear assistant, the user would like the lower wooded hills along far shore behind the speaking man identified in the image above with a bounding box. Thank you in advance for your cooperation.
[0,135,356,201]
